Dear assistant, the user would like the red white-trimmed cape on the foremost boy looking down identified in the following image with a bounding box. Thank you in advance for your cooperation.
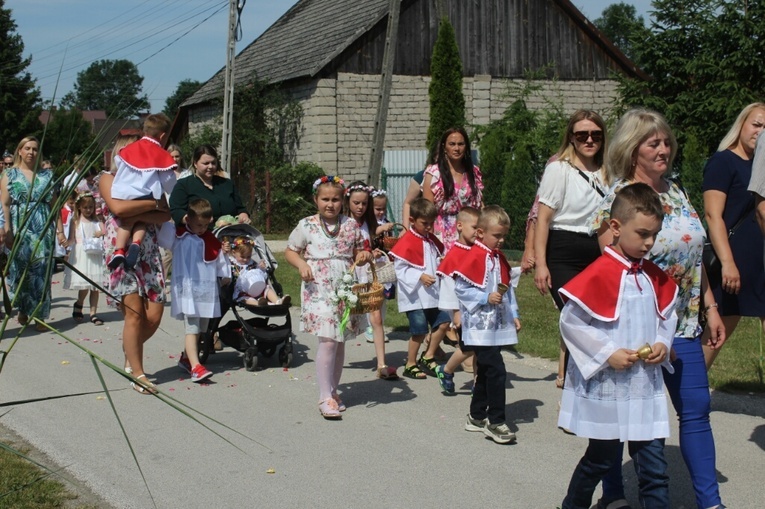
[559,247,677,322]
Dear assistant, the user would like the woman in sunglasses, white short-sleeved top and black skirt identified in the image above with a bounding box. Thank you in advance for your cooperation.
[534,110,606,388]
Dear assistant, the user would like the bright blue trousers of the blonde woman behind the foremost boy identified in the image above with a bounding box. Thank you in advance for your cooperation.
[603,337,722,508]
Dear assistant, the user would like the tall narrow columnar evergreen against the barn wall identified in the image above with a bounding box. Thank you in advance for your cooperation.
[426,18,466,161]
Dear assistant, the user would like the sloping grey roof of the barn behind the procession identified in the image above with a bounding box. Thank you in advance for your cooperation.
[183,0,389,106]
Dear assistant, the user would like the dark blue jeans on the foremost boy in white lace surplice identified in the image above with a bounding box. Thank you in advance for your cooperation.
[562,438,669,509]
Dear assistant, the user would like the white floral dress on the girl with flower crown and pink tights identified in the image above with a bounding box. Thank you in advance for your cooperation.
[287,215,364,341]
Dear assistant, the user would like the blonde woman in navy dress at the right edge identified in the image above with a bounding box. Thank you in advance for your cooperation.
[702,103,765,369]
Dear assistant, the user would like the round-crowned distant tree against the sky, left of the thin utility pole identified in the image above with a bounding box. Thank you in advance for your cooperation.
[61,60,150,118]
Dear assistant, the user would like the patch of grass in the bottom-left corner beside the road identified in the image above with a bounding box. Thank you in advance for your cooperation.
[0,444,95,509]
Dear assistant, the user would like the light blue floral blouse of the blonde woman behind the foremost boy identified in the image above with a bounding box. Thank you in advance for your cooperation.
[590,179,706,339]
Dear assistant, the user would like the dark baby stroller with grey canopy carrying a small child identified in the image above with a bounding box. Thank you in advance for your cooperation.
[199,224,292,371]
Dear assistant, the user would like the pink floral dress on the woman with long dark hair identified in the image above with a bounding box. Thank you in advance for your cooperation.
[425,164,483,254]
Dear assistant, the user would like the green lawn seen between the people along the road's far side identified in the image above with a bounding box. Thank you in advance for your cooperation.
[275,253,765,393]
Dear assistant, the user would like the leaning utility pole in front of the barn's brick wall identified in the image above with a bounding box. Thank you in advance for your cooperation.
[367,0,401,187]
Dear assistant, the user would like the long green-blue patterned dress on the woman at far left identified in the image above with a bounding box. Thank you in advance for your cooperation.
[5,168,56,319]
